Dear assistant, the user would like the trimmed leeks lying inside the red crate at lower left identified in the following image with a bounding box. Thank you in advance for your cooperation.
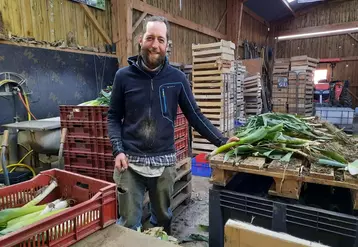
[0,180,70,236]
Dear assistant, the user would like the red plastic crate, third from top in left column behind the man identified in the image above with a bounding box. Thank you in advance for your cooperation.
[64,136,99,152]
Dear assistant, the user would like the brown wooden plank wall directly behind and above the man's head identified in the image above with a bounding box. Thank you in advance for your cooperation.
[133,0,226,64]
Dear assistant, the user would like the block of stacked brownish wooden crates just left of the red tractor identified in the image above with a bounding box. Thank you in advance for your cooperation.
[272,56,319,116]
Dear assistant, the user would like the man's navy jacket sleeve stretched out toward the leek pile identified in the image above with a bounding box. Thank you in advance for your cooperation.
[179,77,229,147]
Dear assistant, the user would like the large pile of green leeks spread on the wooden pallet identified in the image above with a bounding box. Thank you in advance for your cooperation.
[208,113,358,175]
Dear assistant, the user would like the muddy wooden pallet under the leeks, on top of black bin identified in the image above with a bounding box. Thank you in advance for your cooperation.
[209,154,358,209]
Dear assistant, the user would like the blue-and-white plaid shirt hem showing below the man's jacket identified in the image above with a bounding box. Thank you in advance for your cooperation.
[127,153,176,167]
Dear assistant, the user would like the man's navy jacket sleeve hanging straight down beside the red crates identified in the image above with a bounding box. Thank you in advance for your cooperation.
[108,71,124,157]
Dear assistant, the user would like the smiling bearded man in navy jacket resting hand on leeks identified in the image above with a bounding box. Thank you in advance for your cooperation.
[108,16,238,234]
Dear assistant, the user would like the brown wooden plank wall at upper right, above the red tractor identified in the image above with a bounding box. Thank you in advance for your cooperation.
[273,0,358,106]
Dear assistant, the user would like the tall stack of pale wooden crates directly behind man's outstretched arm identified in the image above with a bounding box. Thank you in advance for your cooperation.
[192,40,237,154]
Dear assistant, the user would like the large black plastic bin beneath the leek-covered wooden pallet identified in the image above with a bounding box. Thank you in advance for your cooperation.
[209,175,358,247]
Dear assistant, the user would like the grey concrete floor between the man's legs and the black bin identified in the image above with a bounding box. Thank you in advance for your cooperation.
[172,176,211,247]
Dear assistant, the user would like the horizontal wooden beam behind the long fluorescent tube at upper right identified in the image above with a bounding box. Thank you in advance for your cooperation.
[277,21,358,41]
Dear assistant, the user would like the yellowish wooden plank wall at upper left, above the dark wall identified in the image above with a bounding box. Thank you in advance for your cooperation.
[0,0,112,47]
